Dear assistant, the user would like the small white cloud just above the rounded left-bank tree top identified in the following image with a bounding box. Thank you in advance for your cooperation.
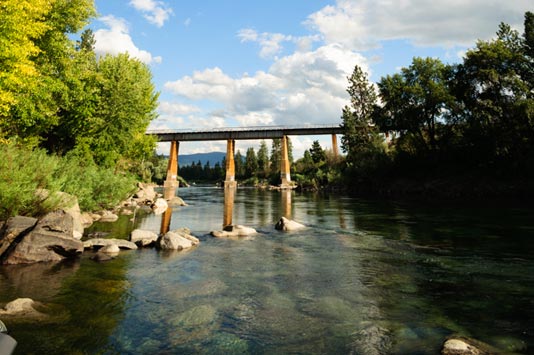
[94,15,162,64]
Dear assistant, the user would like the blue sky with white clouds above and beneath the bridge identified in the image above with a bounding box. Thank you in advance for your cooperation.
[88,0,534,158]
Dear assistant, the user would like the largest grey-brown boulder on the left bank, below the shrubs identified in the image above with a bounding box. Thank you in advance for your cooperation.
[3,210,83,264]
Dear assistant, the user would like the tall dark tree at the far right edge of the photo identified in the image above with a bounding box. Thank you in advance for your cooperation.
[453,13,534,166]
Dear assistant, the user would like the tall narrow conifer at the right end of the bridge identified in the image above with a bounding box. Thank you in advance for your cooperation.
[341,66,382,165]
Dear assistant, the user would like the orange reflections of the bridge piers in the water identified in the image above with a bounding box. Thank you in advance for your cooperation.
[160,185,293,235]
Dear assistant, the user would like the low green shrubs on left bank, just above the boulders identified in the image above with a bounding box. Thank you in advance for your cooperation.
[0,142,135,220]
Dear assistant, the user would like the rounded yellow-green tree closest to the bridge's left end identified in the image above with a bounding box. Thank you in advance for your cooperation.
[87,54,159,167]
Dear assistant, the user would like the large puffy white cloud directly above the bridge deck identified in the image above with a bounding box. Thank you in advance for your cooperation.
[164,45,368,126]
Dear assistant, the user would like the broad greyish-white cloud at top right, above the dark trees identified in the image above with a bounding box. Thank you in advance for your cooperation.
[305,0,532,50]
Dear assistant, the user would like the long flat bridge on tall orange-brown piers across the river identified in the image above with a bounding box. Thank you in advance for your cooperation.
[146,125,343,199]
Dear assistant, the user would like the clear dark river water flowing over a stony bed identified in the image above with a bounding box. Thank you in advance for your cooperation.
[0,187,534,354]
